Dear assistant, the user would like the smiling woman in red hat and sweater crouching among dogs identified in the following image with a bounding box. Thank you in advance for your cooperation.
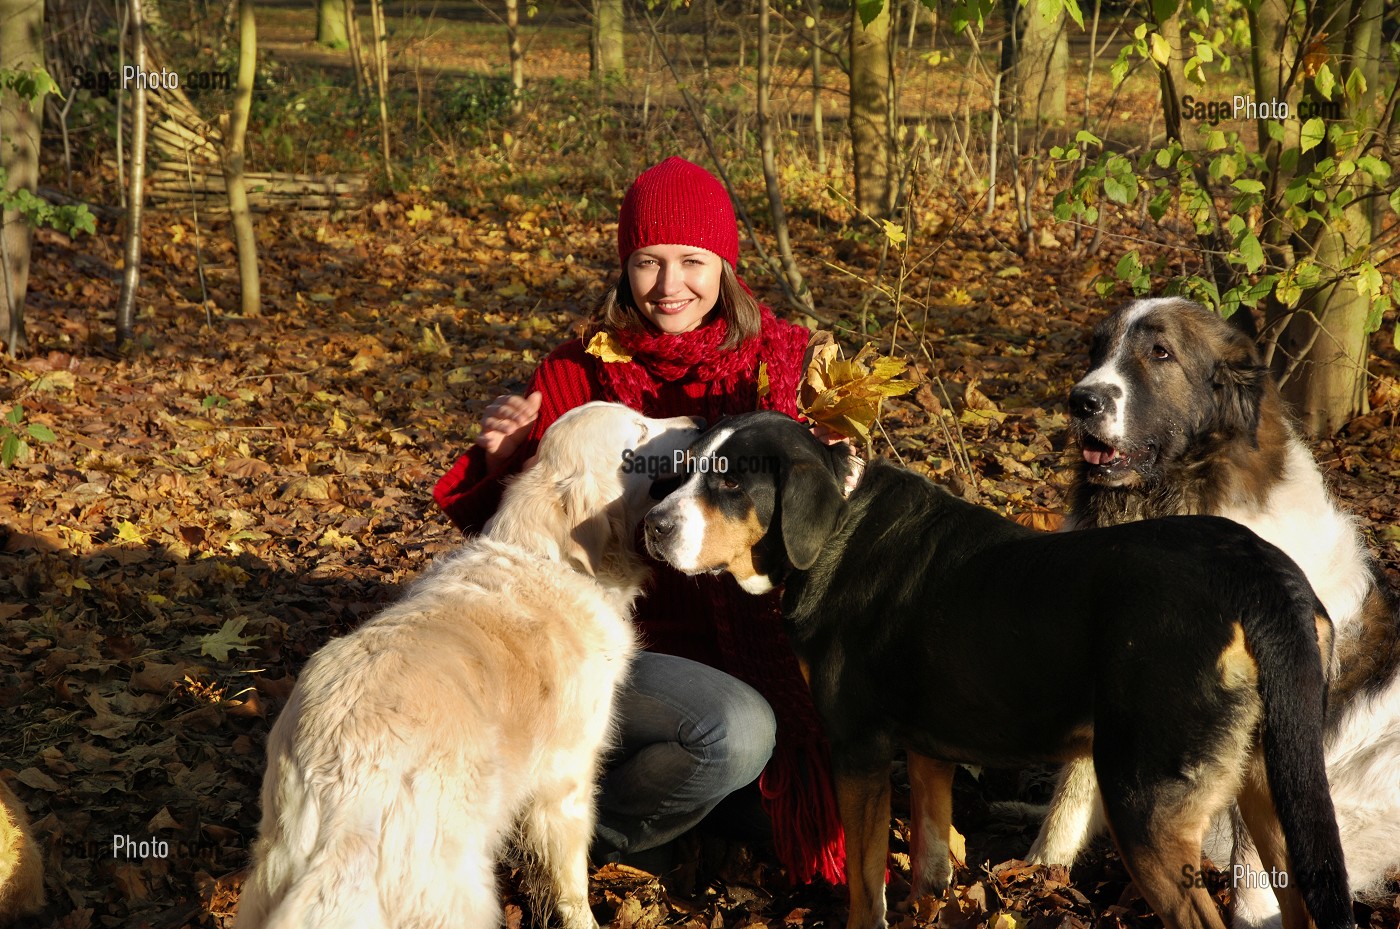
[434,158,844,883]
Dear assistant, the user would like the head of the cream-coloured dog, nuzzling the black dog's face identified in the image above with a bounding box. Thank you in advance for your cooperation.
[486,403,703,585]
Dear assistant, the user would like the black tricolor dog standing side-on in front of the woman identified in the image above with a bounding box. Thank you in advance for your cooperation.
[645,413,1354,929]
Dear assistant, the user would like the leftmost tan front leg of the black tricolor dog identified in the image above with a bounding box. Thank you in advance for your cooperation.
[834,770,889,929]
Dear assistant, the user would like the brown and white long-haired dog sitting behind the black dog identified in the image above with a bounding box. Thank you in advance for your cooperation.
[1030,298,1400,926]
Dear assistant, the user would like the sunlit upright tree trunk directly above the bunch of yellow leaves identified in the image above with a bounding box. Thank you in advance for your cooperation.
[850,0,895,220]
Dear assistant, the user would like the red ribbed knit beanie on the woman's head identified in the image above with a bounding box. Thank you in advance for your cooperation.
[617,158,739,267]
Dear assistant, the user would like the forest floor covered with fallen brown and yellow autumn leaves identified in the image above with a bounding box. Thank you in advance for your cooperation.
[0,8,1400,929]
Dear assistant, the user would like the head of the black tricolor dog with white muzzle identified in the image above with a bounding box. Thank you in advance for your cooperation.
[645,413,855,593]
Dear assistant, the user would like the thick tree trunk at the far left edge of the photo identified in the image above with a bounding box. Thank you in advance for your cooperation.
[0,0,43,355]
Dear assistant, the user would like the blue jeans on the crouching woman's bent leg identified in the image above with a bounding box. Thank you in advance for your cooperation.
[594,652,777,858]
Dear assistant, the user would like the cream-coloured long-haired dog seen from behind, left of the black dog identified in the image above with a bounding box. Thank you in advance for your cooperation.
[237,403,699,929]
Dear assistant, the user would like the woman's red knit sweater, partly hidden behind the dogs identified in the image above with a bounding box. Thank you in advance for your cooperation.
[433,316,844,884]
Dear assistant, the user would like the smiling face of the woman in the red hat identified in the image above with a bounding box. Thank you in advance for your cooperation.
[627,245,724,334]
